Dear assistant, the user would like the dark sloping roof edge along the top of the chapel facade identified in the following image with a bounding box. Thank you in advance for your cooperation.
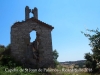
[11,17,54,29]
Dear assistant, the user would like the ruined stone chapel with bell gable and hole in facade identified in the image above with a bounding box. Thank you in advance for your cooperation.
[11,6,54,68]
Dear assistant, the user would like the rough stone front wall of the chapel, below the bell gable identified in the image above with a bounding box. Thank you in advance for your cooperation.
[11,18,53,67]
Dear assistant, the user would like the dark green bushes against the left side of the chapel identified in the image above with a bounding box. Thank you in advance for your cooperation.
[0,44,22,68]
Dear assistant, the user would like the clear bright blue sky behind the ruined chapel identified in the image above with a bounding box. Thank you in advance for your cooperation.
[0,0,100,62]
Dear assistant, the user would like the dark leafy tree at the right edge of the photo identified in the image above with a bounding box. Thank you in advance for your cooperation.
[82,28,100,72]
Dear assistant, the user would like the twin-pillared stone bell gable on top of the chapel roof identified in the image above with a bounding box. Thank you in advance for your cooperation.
[25,6,38,20]
